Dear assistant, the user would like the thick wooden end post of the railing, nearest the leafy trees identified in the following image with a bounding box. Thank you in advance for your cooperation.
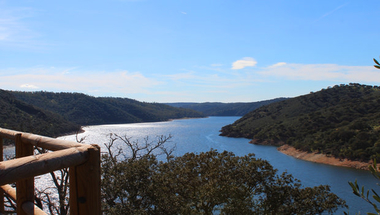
[69,145,101,215]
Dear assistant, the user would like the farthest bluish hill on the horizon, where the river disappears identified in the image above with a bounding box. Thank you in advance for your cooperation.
[166,98,286,116]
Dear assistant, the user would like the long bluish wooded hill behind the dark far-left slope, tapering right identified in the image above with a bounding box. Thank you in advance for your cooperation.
[10,91,204,125]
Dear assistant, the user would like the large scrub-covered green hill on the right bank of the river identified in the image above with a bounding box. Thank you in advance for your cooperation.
[221,84,380,161]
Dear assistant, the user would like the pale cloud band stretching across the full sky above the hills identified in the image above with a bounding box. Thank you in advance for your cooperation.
[0,61,380,101]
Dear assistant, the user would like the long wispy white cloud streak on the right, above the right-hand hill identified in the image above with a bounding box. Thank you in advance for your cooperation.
[162,59,380,92]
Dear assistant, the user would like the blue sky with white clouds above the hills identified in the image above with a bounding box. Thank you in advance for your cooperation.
[0,0,380,102]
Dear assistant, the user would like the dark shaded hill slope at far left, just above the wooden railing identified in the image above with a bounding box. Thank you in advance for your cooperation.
[0,90,80,137]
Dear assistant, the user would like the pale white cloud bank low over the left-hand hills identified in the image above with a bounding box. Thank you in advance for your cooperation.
[0,68,160,96]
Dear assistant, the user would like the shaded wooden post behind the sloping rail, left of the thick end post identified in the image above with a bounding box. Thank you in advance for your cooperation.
[15,133,34,215]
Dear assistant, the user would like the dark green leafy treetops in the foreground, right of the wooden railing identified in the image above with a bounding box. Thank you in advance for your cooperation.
[102,138,345,214]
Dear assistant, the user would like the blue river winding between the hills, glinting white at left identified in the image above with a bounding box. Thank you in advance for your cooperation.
[61,117,378,214]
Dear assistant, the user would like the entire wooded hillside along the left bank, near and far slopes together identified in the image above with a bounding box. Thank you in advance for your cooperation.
[0,90,204,137]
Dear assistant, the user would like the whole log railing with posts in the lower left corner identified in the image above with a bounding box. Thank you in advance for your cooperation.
[0,128,101,215]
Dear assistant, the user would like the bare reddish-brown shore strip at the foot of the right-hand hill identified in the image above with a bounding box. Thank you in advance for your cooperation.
[277,144,372,170]
